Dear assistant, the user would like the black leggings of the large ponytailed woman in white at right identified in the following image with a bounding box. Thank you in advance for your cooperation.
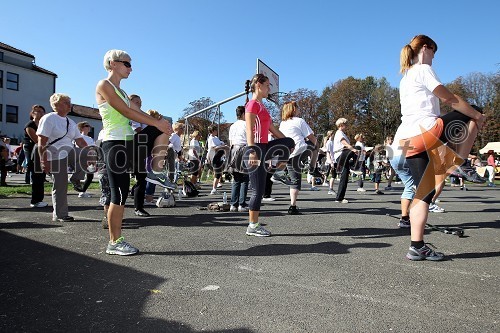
[406,111,471,204]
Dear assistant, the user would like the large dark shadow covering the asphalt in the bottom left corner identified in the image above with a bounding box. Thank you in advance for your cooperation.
[0,232,252,333]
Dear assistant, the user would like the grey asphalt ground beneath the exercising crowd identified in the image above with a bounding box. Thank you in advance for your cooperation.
[0,174,500,332]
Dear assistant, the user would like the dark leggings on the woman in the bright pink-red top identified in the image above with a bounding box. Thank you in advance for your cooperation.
[248,138,295,210]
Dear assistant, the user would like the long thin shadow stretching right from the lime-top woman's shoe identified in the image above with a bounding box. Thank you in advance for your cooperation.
[141,242,391,257]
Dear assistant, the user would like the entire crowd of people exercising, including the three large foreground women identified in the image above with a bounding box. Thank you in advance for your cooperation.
[0,35,499,261]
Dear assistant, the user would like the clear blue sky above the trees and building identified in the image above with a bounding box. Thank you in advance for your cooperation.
[0,0,500,121]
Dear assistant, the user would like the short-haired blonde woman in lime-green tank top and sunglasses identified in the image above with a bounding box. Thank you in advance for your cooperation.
[95,50,172,255]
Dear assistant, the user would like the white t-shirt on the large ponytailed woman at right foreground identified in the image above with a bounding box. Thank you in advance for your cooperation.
[399,64,442,139]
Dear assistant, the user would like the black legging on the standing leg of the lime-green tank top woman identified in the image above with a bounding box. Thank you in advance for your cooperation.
[102,140,133,206]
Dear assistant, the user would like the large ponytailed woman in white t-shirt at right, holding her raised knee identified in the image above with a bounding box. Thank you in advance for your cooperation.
[393,35,485,261]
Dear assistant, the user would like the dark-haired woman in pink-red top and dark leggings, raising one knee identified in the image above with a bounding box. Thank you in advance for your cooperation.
[245,74,295,237]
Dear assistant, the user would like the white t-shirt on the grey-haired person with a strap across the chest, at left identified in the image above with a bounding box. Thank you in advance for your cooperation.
[36,112,82,161]
